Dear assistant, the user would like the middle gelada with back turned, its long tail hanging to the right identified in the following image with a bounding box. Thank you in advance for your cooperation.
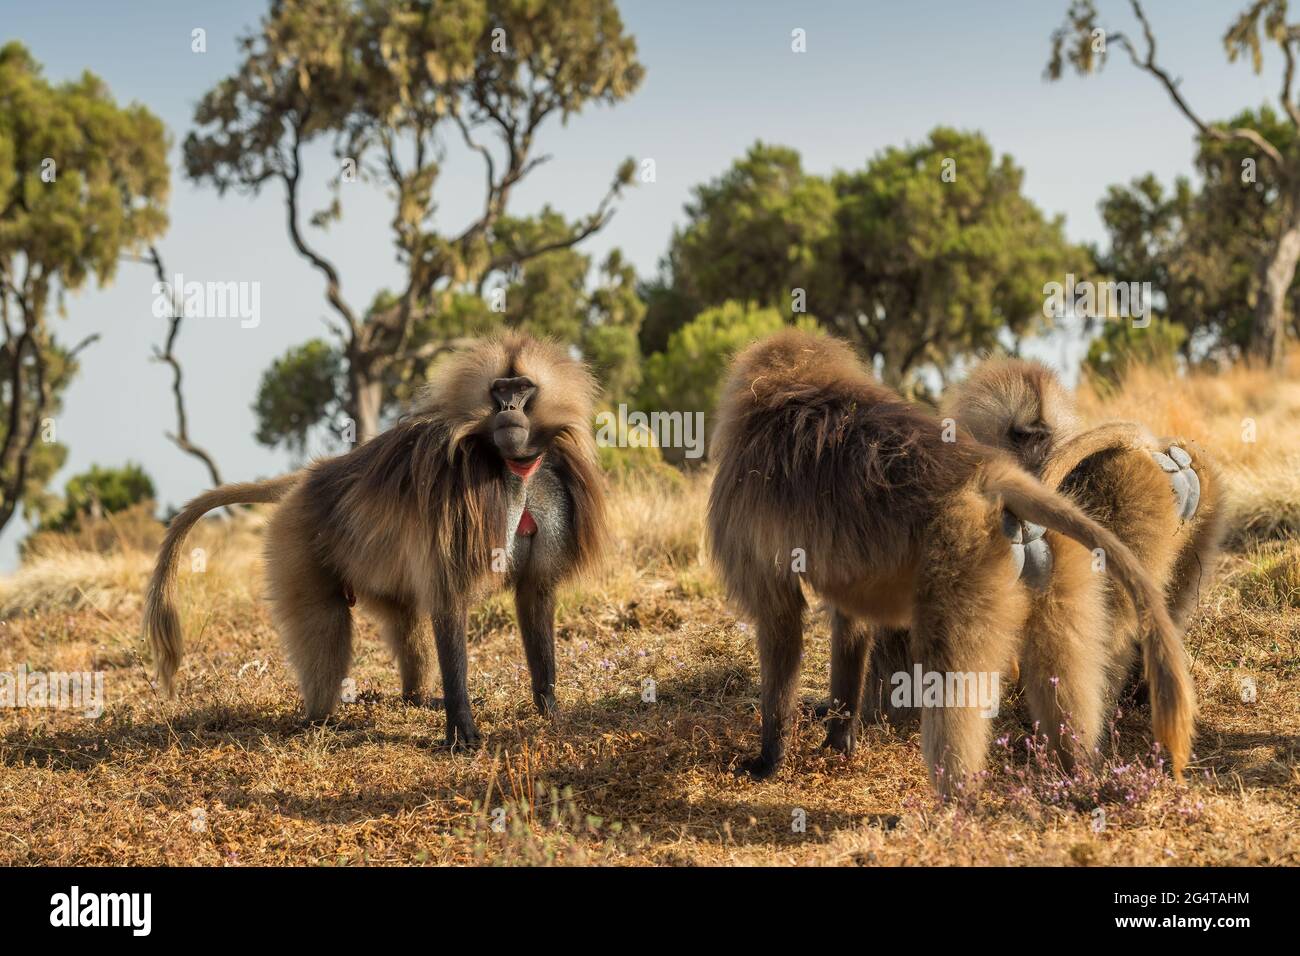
[709,330,1195,792]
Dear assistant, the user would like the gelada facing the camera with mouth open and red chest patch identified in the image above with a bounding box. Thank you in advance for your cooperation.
[144,337,606,747]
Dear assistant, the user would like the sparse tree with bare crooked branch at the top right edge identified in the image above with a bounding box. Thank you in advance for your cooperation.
[1047,0,1300,367]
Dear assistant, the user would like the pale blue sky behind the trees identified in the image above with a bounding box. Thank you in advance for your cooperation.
[0,0,1278,567]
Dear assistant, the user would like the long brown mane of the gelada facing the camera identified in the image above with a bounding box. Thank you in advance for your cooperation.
[307,336,607,593]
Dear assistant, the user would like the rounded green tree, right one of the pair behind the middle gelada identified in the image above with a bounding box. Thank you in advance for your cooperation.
[826,127,1087,389]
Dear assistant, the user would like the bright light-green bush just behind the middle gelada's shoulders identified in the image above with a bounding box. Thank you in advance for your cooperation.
[638,302,816,415]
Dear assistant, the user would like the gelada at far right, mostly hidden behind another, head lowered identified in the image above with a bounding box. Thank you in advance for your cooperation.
[944,359,1225,700]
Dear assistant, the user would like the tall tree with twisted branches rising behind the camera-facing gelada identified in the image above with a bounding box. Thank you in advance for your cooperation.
[185,0,644,441]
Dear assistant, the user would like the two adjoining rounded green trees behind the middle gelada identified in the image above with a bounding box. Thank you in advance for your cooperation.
[646,127,1084,388]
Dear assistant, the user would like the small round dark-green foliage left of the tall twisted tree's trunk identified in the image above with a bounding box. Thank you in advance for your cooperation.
[252,338,343,455]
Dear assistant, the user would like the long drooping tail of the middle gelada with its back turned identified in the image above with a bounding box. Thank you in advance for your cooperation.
[984,459,1196,778]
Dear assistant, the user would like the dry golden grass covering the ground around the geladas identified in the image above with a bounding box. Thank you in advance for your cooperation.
[0,358,1300,865]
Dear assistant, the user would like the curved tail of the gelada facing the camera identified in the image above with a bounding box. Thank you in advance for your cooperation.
[144,472,302,697]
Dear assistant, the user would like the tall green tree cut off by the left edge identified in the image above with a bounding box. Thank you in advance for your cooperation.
[0,43,168,528]
